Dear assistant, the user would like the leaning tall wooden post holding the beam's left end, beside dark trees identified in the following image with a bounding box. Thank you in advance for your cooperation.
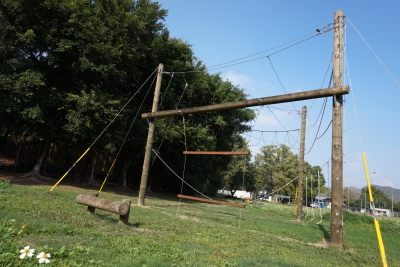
[138,63,164,206]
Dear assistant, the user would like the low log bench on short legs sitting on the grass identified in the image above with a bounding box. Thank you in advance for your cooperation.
[76,194,131,224]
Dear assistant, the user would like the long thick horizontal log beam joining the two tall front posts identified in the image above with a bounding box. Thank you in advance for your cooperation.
[142,86,350,119]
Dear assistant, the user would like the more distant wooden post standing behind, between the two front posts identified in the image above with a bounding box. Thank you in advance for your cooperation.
[297,106,308,222]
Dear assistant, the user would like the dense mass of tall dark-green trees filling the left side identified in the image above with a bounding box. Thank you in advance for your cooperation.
[0,0,254,194]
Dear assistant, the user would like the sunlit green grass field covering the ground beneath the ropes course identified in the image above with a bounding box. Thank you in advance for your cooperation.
[0,178,400,267]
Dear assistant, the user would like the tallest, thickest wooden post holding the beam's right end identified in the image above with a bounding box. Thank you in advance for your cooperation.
[330,10,344,248]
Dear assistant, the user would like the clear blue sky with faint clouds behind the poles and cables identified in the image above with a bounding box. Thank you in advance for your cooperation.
[158,0,400,191]
